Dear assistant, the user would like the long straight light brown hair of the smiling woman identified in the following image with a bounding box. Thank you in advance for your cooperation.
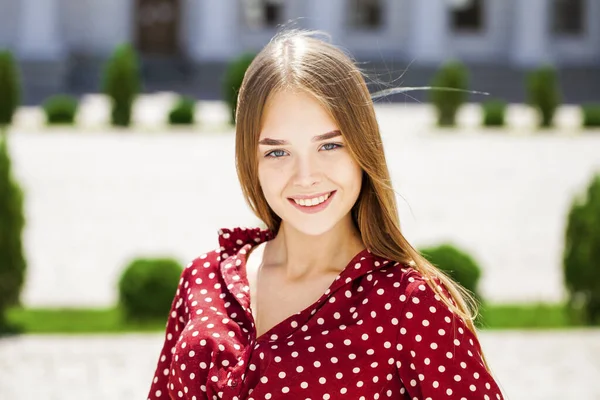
[235,30,489,369]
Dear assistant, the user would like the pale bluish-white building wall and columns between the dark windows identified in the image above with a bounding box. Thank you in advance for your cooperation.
[0,0,600,65]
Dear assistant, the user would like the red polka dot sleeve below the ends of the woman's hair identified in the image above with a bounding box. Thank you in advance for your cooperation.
[396,277,503,400]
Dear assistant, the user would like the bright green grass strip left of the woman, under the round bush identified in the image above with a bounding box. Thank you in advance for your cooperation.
[7,308,167,334]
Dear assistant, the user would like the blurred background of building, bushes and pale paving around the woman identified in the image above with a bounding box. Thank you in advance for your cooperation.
[0,0,600,400]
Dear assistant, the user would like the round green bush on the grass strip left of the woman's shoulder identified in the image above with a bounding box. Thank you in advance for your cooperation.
[119,258,183,321]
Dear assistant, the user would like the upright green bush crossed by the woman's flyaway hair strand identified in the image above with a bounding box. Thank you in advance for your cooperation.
[430,61,468,126]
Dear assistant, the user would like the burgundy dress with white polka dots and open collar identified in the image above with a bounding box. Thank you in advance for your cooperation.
[148,228,503,400]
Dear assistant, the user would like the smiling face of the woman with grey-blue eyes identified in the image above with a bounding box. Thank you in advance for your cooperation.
[258,91,362,235]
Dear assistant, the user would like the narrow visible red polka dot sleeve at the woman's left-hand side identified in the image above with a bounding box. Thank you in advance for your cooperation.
[148,267,189,400]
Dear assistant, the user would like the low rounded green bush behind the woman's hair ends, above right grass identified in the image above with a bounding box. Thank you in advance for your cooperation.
[420,243,482,302]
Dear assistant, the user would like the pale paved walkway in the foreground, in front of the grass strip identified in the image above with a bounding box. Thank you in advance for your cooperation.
[0,330,600,400]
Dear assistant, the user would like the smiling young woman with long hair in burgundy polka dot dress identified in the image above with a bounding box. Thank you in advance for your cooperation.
[148,31,503,400]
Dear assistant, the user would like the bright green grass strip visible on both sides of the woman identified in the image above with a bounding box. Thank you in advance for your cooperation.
[0,304,592,334]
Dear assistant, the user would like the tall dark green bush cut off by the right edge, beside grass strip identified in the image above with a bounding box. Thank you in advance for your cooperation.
[563,174,600,325]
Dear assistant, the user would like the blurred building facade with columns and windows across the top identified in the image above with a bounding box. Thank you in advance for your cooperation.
[0,0,600,103]
